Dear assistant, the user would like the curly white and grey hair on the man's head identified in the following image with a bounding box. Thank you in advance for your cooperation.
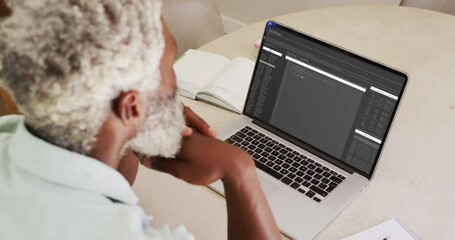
[0,0,164,154]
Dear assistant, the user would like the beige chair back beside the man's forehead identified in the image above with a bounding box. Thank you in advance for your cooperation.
[163,0,224,56]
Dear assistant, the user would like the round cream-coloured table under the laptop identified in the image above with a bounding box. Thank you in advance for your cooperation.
[134,7,455,240]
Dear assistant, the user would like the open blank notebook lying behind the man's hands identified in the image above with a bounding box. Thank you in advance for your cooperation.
[174,49,254,113]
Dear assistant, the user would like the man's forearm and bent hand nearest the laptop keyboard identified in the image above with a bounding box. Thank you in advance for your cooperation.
[151,132,281,240]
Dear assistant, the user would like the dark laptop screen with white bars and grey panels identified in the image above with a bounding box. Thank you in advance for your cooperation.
[244,22,407,177]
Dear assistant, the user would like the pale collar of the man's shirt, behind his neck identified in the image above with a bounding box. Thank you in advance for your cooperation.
[9,118,138,205]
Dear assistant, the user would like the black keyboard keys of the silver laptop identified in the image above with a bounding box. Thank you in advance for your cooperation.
[226,126,345,202]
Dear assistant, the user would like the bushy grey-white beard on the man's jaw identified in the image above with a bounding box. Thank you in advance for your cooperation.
[127,90,186,158]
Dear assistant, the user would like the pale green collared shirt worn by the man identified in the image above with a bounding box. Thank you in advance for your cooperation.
[0,116,194,240]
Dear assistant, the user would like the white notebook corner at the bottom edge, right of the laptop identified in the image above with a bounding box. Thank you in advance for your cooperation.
[342,218,420,240]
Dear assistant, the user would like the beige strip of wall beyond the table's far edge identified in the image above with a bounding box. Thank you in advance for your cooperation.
[213,0,401,32]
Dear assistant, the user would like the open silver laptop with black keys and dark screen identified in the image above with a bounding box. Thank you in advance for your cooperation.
[211,21,408,239]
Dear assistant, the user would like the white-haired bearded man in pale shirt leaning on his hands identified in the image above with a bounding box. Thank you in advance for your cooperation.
[0,0,280,240]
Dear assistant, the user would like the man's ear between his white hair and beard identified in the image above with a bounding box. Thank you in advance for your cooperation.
[113,91,145,127]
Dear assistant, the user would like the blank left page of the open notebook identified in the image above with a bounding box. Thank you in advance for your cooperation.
[174,49,230,98]
